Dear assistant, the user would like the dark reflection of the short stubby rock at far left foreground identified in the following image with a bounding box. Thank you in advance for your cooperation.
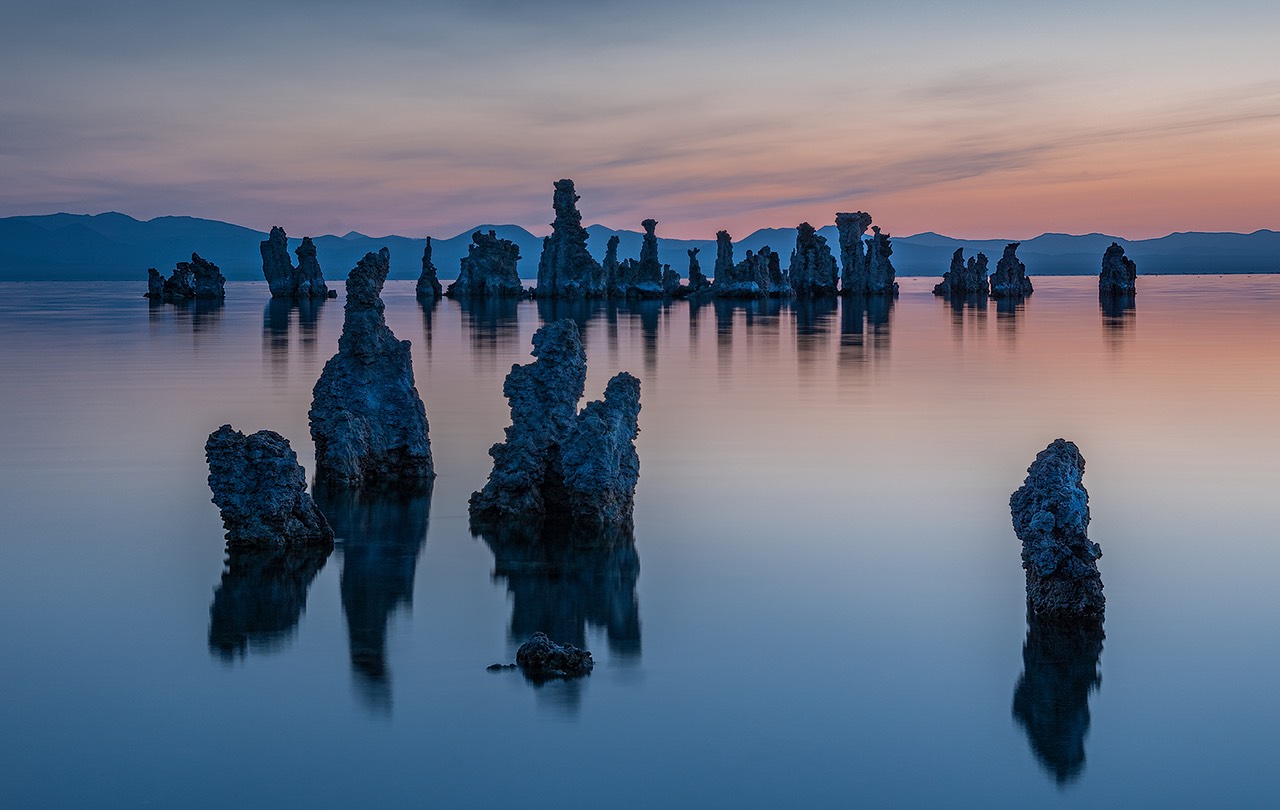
[209,548,330,662]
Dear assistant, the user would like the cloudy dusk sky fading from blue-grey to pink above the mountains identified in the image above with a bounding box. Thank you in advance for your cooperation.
[0,0,1280,239]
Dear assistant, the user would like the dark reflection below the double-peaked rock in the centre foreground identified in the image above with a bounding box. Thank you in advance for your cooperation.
[472,523,640,659]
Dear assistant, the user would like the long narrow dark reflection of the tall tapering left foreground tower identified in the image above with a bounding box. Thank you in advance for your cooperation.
[315,485,431,711]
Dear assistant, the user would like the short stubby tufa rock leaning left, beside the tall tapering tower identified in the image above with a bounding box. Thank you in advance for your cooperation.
[205,425,333,548]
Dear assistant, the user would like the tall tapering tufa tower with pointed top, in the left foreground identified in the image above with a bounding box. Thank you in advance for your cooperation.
[310,248,435,488]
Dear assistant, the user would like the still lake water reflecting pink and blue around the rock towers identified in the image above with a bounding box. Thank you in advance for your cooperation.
[0,276,1280,807]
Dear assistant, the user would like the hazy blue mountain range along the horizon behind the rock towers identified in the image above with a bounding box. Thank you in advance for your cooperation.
[0,214,1280,284]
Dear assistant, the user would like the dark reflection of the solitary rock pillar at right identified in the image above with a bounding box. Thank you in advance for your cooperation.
[1012,615,1105,784]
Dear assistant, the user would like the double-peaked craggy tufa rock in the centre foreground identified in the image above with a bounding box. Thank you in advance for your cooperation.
[471,320,640,526]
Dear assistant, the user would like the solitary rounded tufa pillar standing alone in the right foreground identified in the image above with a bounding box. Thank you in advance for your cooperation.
[1009,439,1106,619]
